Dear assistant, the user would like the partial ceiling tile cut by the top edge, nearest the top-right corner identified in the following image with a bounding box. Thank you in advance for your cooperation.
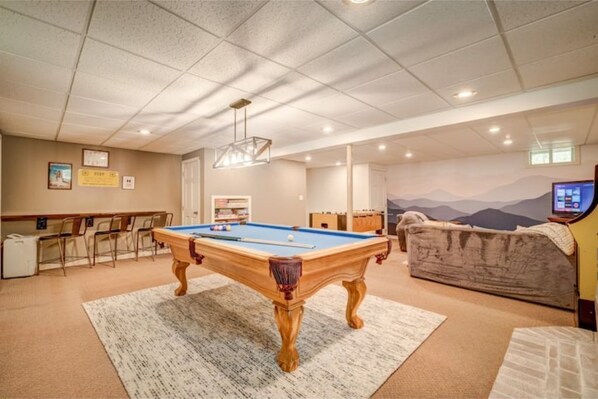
[494,0,587,31]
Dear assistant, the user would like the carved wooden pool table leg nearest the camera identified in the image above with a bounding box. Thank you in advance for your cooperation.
[274,301,305,372]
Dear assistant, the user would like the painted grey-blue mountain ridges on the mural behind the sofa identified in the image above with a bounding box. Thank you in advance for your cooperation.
[387,175,552,233]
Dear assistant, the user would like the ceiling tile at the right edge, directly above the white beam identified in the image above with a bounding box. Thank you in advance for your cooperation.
[518,44,598,89]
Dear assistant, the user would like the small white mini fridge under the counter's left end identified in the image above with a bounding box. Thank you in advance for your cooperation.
[2,234,38,278]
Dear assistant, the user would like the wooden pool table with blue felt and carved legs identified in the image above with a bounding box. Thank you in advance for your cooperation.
[153,223,391,372]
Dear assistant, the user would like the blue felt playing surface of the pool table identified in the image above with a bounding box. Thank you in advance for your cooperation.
[167,223,376,256]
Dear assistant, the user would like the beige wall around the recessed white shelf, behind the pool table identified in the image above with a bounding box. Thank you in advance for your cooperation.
[183,150,307,226]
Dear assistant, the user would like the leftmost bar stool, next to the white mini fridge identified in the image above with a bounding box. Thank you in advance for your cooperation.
[37,216,91,276]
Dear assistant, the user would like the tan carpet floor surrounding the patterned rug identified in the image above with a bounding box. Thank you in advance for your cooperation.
[0,242,574,398]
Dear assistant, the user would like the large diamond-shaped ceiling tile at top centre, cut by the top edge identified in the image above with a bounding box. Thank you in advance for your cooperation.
[228,1,356,68]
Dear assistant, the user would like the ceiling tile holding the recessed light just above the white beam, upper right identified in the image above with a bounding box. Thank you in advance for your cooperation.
[436,69,521,105]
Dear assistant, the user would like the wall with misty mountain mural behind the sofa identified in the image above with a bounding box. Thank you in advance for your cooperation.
[386,144,598,233]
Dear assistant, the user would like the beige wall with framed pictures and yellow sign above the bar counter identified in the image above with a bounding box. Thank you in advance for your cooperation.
[2,135,181,238]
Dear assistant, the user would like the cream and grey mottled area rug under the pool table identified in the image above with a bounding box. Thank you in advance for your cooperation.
[83,274,445,398]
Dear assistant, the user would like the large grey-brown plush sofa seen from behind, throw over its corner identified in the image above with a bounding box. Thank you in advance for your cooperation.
[407,223,577,309]
